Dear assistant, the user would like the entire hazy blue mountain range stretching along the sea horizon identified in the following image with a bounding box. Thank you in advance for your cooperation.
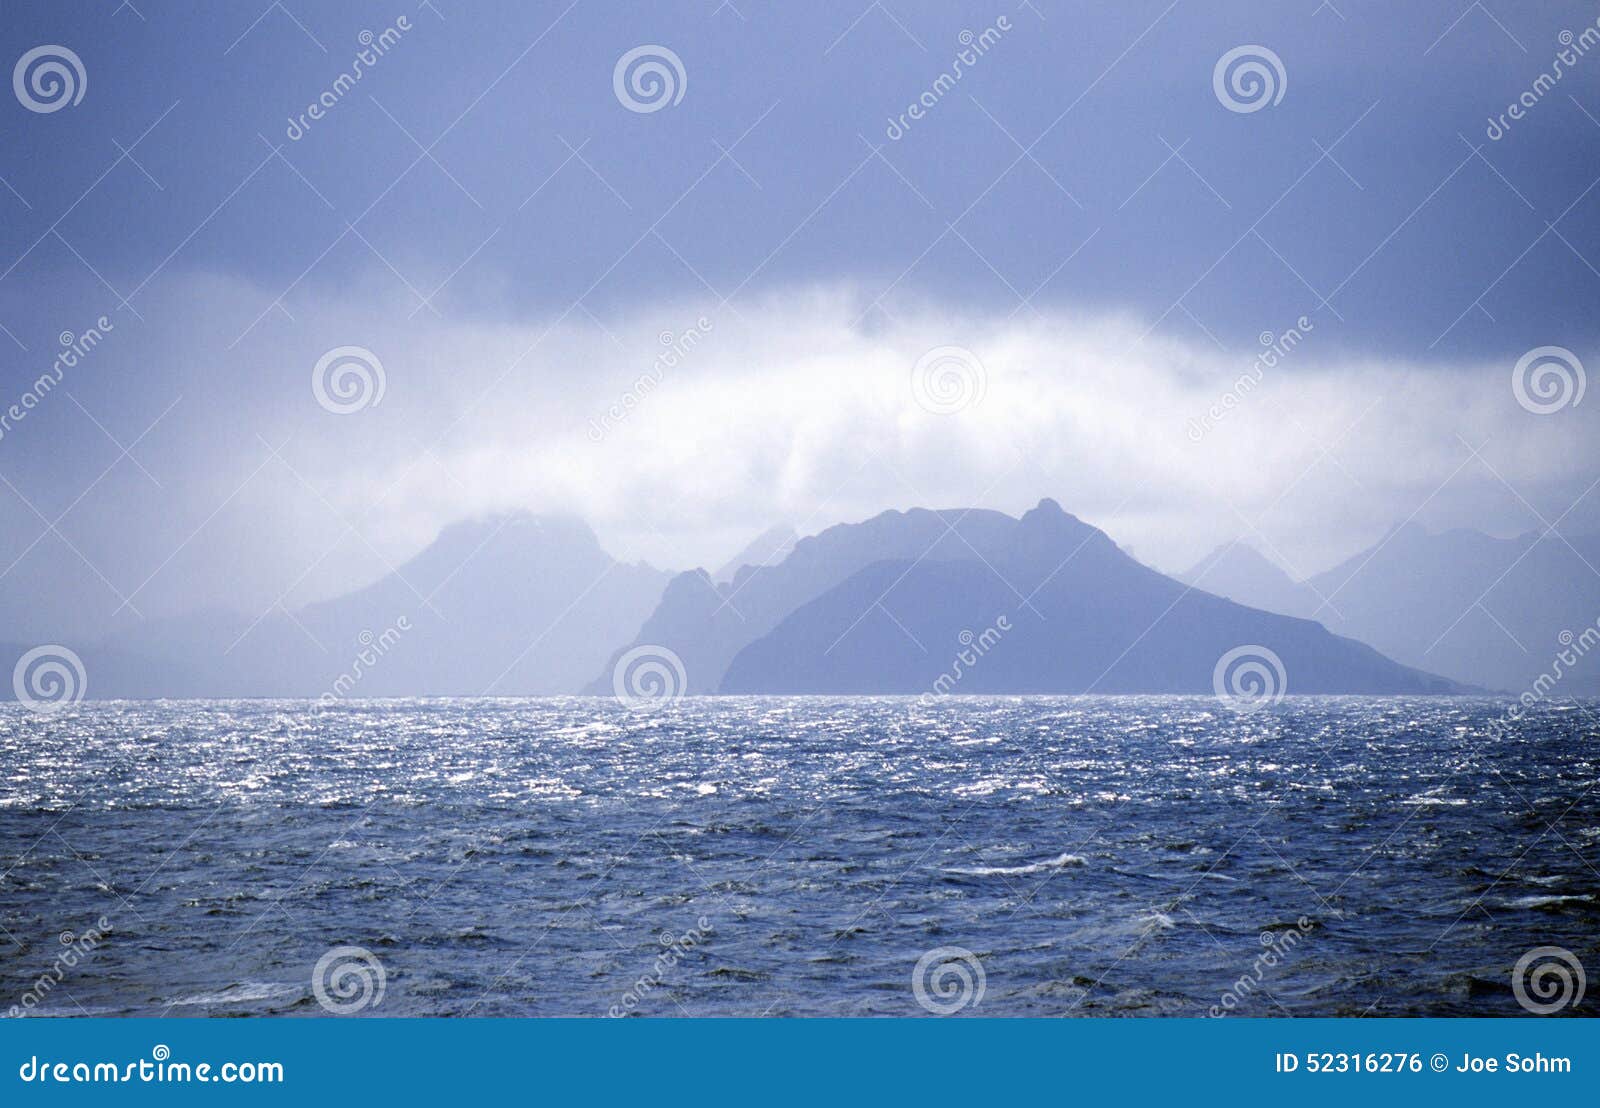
[9,500,1600,698]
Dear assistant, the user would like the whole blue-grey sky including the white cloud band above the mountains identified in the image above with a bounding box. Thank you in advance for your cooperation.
[0,0,1600,634]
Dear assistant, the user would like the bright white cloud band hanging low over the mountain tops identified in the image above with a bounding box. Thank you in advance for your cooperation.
[6,277,1595,630]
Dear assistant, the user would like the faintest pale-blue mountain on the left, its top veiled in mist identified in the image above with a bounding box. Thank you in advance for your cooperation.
[72,514,670,698]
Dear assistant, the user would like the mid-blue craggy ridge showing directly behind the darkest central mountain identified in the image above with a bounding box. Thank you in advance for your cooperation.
[586,508,1016,695]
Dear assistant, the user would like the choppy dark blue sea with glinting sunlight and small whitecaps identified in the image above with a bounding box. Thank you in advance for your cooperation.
[0,698,1600,1017]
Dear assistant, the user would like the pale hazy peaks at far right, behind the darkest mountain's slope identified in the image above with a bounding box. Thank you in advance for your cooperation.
[1181,524,1600,695]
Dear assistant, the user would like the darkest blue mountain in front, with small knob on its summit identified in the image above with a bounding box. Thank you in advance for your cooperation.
[722,500,1459,693]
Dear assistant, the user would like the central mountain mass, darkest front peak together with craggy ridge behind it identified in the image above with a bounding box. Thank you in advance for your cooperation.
[611,500,1459,693]
